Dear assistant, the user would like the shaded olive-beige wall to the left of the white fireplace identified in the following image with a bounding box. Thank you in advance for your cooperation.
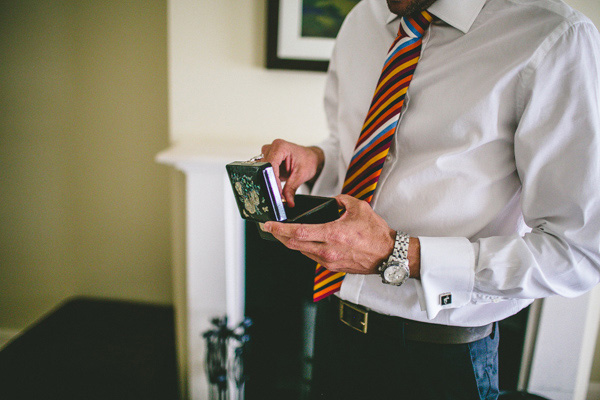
[0,0,172,329]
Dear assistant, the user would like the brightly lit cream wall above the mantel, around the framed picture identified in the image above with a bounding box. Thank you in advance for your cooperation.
[168,0,600,390]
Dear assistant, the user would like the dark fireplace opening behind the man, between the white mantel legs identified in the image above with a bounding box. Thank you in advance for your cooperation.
[245,222,529,400]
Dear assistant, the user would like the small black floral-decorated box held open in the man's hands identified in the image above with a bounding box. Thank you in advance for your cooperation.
[226,161,340,240]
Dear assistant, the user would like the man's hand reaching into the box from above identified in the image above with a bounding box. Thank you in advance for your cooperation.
[262,139,325,207]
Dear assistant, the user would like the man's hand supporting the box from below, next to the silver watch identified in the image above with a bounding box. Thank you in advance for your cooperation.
[265,195,396,274]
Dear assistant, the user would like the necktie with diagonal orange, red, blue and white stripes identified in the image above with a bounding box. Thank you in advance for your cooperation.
[313,11,433,301]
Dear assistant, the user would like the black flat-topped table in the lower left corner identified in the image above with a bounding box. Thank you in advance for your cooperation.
[0,298,179,400]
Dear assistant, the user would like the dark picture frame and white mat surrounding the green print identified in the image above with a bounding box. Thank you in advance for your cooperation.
[266,0,356,72]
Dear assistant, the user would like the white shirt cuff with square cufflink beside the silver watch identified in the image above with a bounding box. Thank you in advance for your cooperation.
[417,237,475,319]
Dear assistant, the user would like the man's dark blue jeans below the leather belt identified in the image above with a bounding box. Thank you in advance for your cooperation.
[311,300,499,400]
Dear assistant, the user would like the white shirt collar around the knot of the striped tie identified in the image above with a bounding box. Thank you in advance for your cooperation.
[387,0,486,33]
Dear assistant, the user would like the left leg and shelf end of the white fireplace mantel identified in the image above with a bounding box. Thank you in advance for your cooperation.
[156,143,256,400]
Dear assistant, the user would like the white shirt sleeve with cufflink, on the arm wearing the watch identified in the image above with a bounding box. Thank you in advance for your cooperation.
[418,22,600,319]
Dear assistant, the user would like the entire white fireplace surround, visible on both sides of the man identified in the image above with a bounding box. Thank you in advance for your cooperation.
[156,143,600,400]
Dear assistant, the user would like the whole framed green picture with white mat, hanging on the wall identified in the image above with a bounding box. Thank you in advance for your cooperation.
[267,0,359,71]
